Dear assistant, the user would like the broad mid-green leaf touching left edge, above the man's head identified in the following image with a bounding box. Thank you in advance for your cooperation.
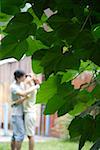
[0,36,28,60]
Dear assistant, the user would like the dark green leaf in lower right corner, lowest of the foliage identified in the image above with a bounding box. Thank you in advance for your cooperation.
[69,115,95,150]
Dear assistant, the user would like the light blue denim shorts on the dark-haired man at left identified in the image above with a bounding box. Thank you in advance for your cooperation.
[11,116,25,141]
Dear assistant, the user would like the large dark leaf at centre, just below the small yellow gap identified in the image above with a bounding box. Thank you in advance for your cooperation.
[41,44,80,75]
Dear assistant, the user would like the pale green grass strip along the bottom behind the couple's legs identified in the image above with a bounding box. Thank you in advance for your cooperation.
[0,141,91,150]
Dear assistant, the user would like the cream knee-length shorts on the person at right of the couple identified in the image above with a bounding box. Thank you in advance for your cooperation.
[24,112,36,136]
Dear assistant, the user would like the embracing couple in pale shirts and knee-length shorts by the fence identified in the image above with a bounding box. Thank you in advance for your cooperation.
[11,70,40,150]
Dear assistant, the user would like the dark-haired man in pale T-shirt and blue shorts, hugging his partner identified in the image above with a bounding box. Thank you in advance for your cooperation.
[11,70,39,150]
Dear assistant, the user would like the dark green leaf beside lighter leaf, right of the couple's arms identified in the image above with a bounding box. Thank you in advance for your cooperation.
[58,82,78,116]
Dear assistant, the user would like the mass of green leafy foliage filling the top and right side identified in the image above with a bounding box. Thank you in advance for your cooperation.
[0,0,100,150]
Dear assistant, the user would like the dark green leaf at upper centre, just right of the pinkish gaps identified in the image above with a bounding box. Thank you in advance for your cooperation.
[48,14,79,44]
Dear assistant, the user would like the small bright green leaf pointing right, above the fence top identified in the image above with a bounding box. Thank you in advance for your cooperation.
[26,37,48,56]
